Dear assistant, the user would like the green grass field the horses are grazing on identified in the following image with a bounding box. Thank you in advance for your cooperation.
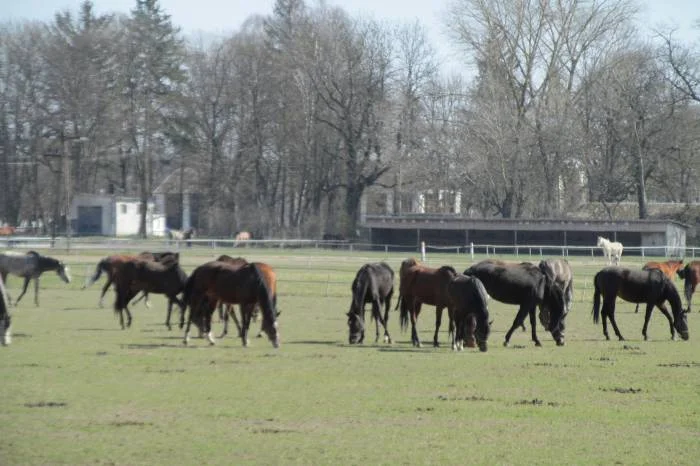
[0,250,700,466]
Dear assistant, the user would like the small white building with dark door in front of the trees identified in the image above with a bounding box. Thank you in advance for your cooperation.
[70,194,165,236]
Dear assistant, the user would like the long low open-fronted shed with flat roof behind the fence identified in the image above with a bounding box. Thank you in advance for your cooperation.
[361,214,688,255]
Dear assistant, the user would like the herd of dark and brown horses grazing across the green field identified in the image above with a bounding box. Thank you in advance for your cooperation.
[0,251,700,351]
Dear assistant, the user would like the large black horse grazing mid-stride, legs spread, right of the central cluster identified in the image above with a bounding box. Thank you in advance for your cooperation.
[464,259,566,346]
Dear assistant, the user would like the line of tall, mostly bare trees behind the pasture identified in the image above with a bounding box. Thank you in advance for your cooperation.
[0,0,700,236]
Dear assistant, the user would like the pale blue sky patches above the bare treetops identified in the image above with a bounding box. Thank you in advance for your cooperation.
[0,0,700,75]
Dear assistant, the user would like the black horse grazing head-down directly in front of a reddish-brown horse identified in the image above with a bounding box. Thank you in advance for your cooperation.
[447,274,491,352]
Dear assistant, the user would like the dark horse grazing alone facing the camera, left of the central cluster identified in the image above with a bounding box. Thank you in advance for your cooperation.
[347,262,394,345]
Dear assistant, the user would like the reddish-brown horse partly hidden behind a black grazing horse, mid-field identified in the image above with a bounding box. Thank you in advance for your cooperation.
[396,258,457,348]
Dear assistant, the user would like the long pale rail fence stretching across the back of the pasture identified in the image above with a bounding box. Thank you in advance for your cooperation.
[0,236,700,259]
